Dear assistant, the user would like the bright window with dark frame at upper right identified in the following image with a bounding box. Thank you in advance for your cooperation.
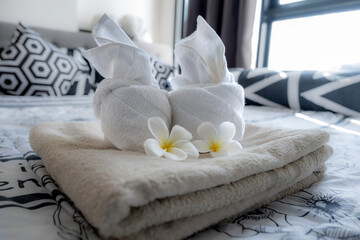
[257,0,360,70]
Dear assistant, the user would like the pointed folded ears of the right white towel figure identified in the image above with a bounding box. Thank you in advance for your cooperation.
[171,16,234,89]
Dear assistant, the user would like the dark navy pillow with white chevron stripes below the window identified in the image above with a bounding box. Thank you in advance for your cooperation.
[238,69,360,116]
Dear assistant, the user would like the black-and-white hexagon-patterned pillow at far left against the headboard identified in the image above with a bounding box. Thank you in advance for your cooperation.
[0,23,95,96]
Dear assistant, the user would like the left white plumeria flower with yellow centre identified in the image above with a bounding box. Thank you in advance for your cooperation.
[144,117,199,160]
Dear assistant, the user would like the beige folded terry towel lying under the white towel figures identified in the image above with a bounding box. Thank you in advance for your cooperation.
[30,122,332,239]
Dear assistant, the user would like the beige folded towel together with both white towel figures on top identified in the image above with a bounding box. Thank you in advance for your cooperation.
[30,16,332,240]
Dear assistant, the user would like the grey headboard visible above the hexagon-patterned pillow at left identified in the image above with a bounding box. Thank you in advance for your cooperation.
[0,22,96,49]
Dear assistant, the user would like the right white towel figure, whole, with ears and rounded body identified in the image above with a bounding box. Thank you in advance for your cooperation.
[169,16,245,141]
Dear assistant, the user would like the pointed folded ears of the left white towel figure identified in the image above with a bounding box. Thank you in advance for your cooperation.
[83,15,157,86]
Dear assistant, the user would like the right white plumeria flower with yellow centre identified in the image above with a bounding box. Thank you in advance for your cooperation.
[193,122,242,157]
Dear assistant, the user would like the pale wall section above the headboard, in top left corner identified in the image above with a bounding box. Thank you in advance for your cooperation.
[0,0,78,31]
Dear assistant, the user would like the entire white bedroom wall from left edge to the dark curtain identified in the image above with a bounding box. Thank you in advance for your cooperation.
[0,0,175,47]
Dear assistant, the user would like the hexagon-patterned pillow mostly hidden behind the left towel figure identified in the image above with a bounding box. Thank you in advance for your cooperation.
[95,56,174,91]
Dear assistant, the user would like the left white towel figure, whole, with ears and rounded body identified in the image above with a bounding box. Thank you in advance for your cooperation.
[84,15,171,152]
